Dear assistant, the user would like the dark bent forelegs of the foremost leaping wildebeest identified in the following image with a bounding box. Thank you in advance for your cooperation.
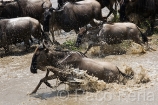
[31,70,57,94]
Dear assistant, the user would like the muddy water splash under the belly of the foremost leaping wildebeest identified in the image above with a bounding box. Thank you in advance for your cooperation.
[68,69,106,92]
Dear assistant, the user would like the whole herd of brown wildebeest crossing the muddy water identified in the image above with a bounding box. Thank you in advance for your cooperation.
[0,0,158,93]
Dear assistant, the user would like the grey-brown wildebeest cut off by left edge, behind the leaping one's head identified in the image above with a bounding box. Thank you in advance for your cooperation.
[0,17,44,53]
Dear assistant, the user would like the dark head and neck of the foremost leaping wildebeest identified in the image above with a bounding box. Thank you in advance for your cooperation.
[30,41,69,73]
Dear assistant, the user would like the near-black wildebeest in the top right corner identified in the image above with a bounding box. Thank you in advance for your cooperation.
[120,0,158,35]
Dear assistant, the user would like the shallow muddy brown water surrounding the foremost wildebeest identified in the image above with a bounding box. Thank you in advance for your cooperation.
[0,34,158,105]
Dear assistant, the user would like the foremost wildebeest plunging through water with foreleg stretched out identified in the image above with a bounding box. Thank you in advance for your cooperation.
[30,42,133,93]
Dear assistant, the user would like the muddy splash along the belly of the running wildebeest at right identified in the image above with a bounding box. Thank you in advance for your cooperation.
[88,41,146,56]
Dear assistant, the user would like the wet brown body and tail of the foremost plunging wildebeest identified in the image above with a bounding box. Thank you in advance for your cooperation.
[60,52,132,83]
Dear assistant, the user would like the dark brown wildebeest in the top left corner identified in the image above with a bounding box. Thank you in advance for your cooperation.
[0,0,52,24]
